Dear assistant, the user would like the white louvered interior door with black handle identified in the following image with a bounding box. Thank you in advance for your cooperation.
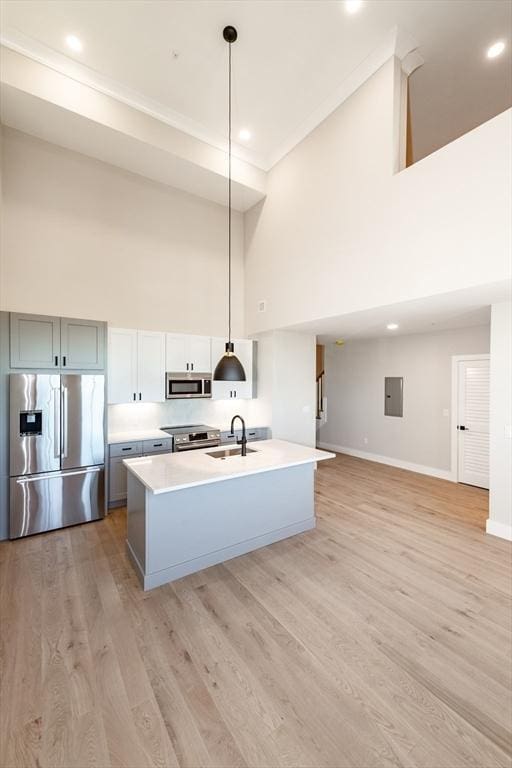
[457,360,489,488]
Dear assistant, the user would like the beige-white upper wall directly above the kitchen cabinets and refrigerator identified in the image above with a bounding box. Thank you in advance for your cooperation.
[0,128,244,336]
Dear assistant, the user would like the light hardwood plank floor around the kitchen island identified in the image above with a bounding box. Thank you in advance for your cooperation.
[0,456,512,768]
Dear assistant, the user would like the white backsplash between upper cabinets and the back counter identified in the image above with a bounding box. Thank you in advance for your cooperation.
[108,399,270,432]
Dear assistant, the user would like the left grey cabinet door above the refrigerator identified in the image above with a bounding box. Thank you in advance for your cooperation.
[10,312,60,368]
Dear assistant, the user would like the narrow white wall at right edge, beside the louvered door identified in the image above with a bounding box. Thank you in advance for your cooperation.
[487,302,512,539]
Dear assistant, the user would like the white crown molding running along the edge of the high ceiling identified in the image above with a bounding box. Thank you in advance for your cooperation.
[0,27,423,172]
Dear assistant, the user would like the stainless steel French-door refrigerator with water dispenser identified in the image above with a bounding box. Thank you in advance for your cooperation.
[9,373,105,539]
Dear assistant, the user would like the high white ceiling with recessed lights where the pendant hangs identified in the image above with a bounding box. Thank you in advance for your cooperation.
[1,0,512,168]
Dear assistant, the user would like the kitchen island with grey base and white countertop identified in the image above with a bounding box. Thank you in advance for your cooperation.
[124,440,335,590]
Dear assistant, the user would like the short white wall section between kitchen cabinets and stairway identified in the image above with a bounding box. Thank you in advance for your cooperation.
[256,331,316,446]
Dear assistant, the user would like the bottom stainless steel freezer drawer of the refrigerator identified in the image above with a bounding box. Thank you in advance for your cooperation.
[9,466,104,539]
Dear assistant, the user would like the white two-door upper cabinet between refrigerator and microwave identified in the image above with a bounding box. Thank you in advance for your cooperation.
[108,328,165,404]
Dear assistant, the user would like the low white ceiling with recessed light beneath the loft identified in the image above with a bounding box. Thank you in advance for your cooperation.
[288,281,512,343]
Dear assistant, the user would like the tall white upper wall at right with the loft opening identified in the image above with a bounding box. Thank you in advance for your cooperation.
[245,55,512,333]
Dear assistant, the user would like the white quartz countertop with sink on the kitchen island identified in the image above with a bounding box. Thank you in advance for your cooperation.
[123,440,335,494]
